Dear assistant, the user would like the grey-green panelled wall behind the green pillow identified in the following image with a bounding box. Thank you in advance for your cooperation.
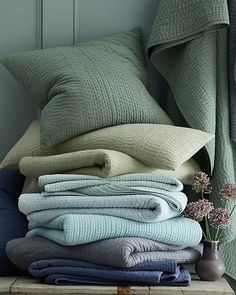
[0,0,159,160]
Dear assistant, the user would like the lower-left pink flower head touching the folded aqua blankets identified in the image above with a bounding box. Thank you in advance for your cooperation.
[184,199,214,222]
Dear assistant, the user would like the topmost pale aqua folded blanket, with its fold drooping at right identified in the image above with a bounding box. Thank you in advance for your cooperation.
[36,173,187,214]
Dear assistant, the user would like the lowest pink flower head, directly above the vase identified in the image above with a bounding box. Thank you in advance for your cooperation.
[209,208,230,229]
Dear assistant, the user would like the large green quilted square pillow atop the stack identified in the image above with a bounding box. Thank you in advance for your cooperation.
[1,29,171,149]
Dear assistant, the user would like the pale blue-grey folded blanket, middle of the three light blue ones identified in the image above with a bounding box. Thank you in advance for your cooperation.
[19,192,187,226]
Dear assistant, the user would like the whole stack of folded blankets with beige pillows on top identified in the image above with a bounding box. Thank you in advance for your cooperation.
[1,121,213,286]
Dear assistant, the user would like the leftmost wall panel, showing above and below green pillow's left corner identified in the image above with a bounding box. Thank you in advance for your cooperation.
[0,0,37,160]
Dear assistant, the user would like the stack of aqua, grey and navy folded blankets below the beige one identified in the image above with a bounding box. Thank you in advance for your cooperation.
[7,173,202,285]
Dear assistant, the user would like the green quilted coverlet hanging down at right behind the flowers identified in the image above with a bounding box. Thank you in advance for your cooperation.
[147,0,236,279]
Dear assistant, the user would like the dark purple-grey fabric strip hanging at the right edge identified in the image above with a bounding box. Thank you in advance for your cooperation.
[228,0,236,142]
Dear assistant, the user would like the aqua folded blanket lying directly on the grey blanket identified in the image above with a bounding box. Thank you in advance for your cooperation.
[27,214,202,247]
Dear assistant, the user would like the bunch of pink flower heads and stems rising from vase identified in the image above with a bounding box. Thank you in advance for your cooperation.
[184,172,236,240]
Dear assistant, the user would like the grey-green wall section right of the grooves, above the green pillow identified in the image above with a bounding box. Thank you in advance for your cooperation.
[75,0,159,42]
